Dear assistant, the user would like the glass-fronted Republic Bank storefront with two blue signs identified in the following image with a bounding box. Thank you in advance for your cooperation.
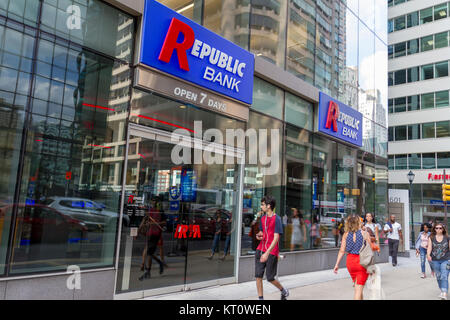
[0,0,387,299]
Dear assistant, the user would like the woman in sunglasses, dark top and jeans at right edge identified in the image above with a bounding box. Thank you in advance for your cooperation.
[427,223,450,300]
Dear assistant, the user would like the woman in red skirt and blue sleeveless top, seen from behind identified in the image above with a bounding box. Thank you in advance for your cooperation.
[334,216,370,300]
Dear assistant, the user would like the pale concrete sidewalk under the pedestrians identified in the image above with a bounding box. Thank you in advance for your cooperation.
[144,251,446,300]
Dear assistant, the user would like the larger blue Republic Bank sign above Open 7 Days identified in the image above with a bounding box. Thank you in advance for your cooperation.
[140,0,255,104]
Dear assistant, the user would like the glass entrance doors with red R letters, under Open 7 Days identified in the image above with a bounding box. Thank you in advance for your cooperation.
[116,125,242,297]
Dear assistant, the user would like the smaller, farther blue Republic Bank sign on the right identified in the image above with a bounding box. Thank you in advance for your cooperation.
[318,92,363,147]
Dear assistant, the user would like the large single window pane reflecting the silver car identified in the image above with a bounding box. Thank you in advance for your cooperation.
[10,40,130,274]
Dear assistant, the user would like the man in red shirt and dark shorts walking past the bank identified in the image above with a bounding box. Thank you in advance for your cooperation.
[255,196,289,300]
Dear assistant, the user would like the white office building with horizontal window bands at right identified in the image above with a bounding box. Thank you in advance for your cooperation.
[388,0,450,240]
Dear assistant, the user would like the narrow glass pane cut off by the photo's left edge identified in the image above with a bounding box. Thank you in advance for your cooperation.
[0,20,30,274]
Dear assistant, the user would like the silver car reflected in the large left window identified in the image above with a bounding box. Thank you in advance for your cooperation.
[44,197,130,231]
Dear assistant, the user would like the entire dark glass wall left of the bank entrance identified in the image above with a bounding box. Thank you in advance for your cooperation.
[0,0,134,275]
